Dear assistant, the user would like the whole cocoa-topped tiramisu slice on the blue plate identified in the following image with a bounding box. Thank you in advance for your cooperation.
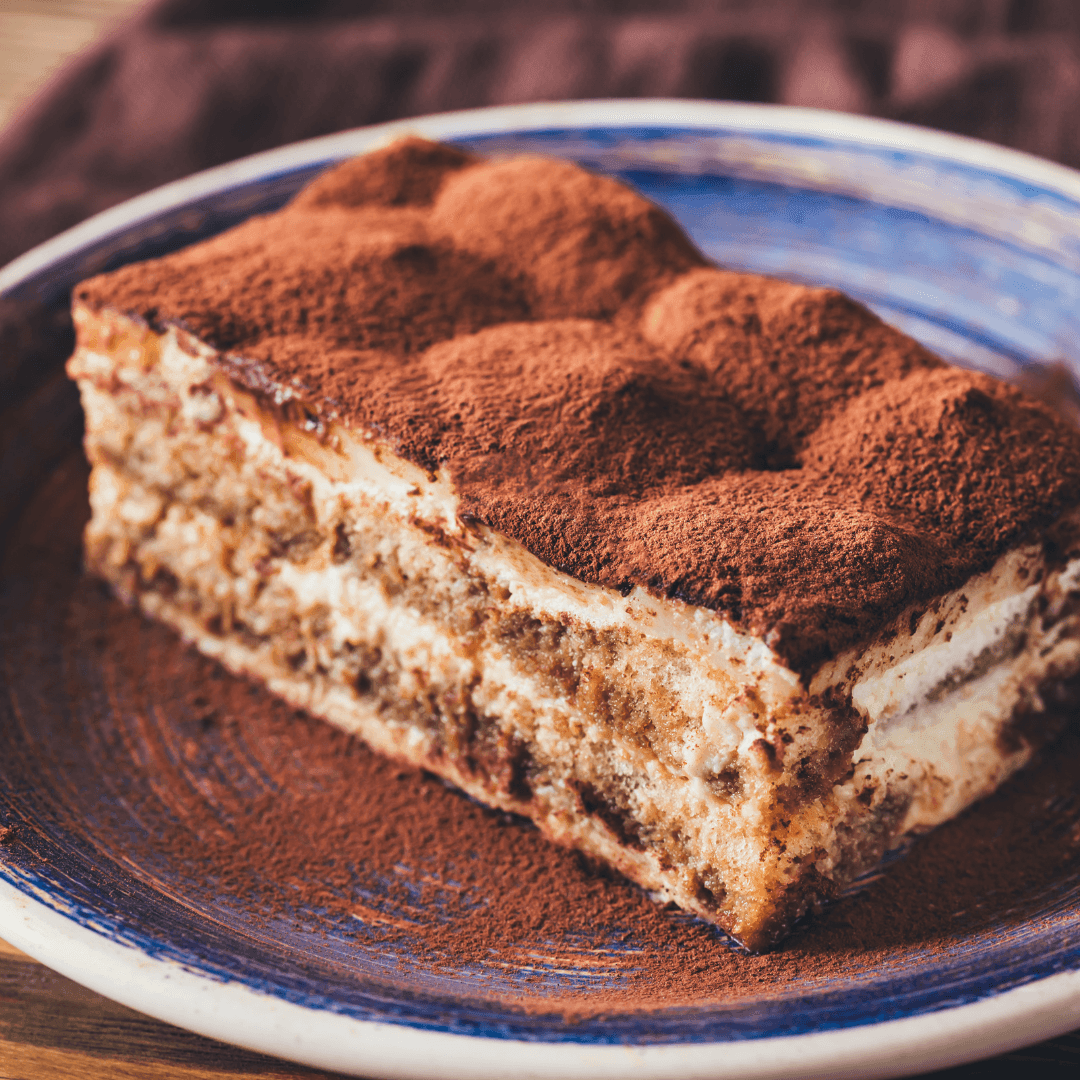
[63,140,1080,949]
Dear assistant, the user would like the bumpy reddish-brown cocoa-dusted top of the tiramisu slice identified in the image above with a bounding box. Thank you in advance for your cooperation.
[77,139,1080,678]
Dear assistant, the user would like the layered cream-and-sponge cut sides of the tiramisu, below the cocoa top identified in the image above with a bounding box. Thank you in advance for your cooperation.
[69,307,1080,948]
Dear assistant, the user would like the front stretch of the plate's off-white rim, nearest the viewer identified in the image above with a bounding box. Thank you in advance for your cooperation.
[0,878,1080,1080]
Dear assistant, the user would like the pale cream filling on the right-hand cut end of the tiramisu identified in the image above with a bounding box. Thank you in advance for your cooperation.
[850,550,1080,832]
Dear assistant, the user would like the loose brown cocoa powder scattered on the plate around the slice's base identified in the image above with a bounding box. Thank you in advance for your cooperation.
[6,458,1080,1020]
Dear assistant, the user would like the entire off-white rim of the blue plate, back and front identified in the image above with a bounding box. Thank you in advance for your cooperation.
[6,99,1080,1078]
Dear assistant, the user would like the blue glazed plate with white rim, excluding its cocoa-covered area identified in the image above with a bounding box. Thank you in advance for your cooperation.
[0,102,1080,1078]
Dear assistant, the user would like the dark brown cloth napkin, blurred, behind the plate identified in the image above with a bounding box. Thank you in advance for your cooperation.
[0,0,1080,265]
